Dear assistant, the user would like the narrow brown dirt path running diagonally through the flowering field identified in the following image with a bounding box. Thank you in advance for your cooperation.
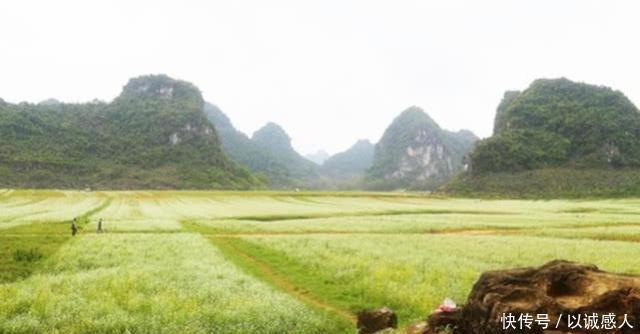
[209,237,356,324]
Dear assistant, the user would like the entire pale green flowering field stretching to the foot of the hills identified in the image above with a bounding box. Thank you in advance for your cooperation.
[0,190,640,334]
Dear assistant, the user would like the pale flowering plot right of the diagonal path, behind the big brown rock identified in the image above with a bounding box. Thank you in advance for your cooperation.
[240,234,640,325]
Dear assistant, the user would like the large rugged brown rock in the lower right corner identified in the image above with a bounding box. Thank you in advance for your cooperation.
[423,261,640,334]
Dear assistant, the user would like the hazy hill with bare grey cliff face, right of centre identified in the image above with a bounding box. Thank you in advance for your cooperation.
[367,107,477,190]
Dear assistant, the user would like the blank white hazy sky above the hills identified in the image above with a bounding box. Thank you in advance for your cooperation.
[0,0,640,153]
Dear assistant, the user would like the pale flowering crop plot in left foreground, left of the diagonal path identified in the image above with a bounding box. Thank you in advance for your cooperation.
[0,233,350,333]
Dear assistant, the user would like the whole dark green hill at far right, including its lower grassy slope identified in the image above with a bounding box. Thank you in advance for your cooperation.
[449,78,640,196]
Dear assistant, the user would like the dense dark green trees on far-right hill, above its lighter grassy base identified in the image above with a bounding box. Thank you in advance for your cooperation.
[471,79,640,173]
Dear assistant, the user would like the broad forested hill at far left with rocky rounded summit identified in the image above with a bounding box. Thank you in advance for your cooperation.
[0,75,260,189]
